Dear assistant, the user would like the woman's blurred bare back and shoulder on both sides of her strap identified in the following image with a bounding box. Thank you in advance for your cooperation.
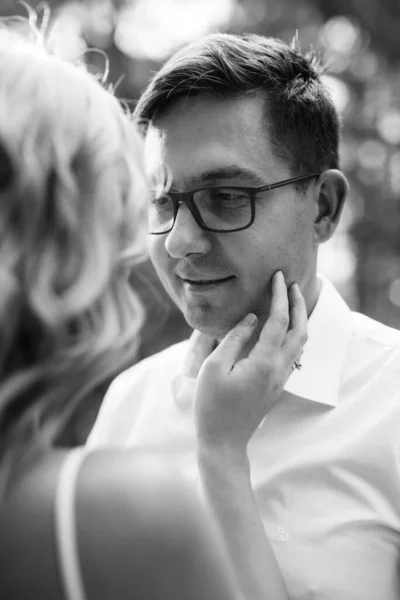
[0,450,233,600]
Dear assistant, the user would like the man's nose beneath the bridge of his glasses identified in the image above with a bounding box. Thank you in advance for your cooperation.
[165,202,211,258]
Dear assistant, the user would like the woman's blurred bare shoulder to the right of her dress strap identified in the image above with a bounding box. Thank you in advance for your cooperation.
[77,450,233,600]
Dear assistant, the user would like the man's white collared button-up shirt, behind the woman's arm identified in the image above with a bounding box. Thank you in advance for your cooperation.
[88,279,400,600]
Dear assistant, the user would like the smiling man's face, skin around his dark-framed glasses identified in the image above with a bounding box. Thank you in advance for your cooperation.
[150,96,316,338]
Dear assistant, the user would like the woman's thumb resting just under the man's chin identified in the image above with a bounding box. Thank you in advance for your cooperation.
[206,313,258,373]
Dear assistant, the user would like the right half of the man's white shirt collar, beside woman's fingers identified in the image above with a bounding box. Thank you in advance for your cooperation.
[284,275,353,406]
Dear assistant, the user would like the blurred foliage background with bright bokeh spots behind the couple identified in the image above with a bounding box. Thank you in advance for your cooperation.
[0,0,400,444]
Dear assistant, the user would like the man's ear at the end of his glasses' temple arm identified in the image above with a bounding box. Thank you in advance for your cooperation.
[314,169,349,244]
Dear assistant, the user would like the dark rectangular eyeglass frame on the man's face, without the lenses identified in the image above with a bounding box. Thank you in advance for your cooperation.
[149,172,321,235]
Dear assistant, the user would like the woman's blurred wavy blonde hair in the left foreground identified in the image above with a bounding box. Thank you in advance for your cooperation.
[0,10,147,468]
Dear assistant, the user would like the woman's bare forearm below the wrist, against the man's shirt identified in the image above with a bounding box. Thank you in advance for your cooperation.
[198,443,288,600]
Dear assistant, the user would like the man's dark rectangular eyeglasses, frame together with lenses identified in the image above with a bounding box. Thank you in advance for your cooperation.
[148,173,320,235]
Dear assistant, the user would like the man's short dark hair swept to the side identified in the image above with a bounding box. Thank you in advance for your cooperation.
[135,33,339,175]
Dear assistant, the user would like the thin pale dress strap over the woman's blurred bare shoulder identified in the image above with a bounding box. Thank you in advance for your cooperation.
[54,448,87,600]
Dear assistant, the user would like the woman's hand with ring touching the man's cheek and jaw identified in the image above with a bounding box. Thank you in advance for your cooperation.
[195,271,307,451]
